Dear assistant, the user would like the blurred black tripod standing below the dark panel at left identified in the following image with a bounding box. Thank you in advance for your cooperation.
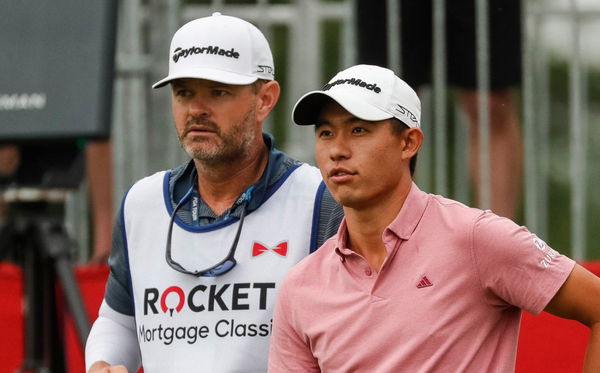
[0,189,90,373]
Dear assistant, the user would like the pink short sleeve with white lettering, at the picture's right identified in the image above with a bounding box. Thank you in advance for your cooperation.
[472,212,575,315]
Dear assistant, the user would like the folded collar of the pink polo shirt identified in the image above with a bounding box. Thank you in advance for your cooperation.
[335,182,429,256]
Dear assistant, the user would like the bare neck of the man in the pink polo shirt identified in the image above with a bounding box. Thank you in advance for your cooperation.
[344,180,412,271]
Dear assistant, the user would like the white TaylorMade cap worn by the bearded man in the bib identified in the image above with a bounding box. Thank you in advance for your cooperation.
[152,13,275,88]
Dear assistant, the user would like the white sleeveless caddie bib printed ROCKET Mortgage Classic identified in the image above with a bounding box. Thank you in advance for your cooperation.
[123,164,321,373]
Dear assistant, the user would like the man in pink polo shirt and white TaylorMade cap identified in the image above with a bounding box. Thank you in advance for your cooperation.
[269,65,600,373]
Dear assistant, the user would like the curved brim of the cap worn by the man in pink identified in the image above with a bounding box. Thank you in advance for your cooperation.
[292,91,393,126]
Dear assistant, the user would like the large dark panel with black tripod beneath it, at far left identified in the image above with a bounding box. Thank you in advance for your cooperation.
[0,0,117,372]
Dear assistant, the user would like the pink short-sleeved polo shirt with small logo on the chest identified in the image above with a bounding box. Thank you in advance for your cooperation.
[269,184,575,373]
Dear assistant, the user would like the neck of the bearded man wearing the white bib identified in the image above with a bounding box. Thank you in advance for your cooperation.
[194,145,269,215]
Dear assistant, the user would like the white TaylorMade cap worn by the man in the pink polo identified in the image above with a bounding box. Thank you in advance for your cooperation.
[292,65,421,128]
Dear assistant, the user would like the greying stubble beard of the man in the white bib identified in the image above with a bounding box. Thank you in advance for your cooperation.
[179,103,256,167]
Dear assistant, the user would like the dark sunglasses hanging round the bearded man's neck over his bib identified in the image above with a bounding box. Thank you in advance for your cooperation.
[165,186,254,277]
